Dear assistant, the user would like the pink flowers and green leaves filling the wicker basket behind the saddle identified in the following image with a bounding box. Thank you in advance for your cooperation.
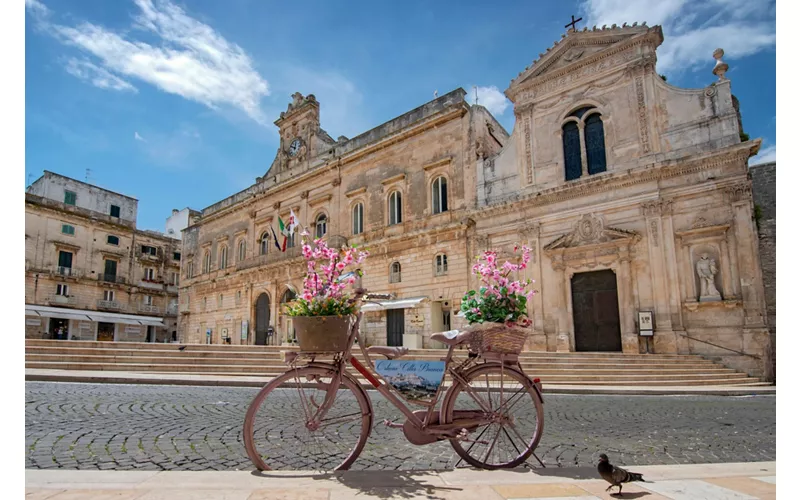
[461,246,536,327]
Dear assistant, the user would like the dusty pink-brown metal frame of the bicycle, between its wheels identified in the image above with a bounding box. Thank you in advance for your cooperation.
[294,311,542,442]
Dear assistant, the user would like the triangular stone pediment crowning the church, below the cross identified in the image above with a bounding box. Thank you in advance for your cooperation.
[506,23,664,100]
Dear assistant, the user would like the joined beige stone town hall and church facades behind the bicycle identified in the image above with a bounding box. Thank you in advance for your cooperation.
[179,24,770,376]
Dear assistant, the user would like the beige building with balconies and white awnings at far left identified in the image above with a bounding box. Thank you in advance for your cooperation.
[25,171,194,342]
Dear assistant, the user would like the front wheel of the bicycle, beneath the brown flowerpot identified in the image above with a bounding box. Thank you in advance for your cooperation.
[244,366,372,471]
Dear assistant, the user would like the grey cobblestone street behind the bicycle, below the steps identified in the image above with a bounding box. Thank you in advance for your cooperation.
[25,382,776,470]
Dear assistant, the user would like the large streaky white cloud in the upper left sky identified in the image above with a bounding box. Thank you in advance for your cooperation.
[34,0,269,124]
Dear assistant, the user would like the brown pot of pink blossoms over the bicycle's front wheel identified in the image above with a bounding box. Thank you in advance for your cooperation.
[287,231,369,352]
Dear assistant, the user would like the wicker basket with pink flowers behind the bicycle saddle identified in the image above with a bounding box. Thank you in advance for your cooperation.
[461,246,536,354]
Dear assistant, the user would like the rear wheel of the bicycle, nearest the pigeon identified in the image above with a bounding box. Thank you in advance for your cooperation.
[440,363,544,469]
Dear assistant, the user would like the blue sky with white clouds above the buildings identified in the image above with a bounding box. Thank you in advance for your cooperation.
[25,0,776,230]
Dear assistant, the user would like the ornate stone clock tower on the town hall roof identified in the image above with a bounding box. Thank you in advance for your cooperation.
[265,92,336,177]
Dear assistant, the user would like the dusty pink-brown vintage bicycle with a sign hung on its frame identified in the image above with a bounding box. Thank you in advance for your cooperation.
[243,289,544,471]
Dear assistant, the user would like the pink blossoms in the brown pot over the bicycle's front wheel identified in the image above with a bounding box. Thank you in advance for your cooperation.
[287,231,369,316]
